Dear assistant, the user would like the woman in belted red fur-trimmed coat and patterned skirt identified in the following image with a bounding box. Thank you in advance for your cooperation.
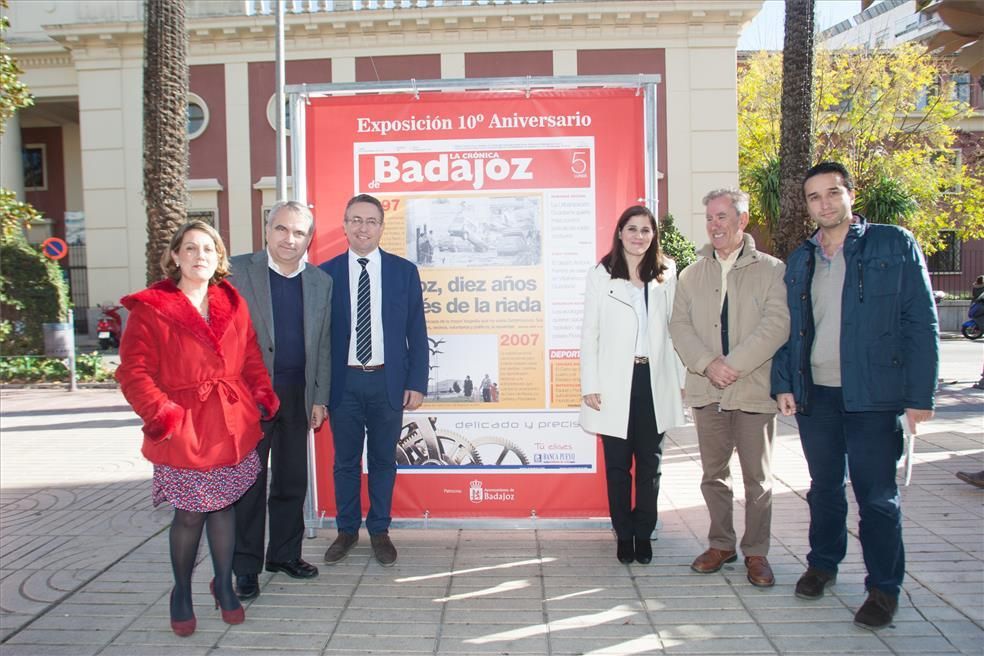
[116,221,280,636]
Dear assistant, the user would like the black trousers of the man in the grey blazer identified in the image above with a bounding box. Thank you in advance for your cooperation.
[232,385,309,576]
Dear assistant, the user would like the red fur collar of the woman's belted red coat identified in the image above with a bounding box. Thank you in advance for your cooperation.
[120,279,242,355]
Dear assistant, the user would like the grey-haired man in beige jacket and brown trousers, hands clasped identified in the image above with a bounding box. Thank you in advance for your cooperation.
[670,189,789,587]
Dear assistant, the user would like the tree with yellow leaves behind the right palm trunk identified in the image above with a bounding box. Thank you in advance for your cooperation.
[738,44,984,254]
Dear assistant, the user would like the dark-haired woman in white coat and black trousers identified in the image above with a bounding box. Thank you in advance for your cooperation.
[581,205,684,564]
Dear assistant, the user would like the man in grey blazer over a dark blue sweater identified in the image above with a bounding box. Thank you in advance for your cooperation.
[229,201,332,599]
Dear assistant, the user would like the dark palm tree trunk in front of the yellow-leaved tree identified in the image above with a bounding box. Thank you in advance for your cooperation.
[773,0,815,259]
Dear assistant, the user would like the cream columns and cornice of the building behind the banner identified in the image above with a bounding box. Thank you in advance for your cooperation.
[13,0,762,305]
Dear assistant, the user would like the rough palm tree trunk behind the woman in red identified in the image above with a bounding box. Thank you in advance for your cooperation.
[143,0,188,285]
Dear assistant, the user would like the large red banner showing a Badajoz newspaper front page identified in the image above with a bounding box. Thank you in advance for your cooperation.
[299,89,646,518]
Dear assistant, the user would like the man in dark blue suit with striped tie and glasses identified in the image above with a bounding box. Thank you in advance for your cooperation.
[321,194,430,566]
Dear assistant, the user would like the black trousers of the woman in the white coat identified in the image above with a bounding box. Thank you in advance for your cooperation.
[601,364,664,540]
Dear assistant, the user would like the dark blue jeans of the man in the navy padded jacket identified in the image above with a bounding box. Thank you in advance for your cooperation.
[796,385,905,597]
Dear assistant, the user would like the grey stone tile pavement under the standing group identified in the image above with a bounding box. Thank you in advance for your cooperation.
[0,346,984,656]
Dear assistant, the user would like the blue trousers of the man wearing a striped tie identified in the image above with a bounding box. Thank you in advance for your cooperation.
[329,369,403,535]
